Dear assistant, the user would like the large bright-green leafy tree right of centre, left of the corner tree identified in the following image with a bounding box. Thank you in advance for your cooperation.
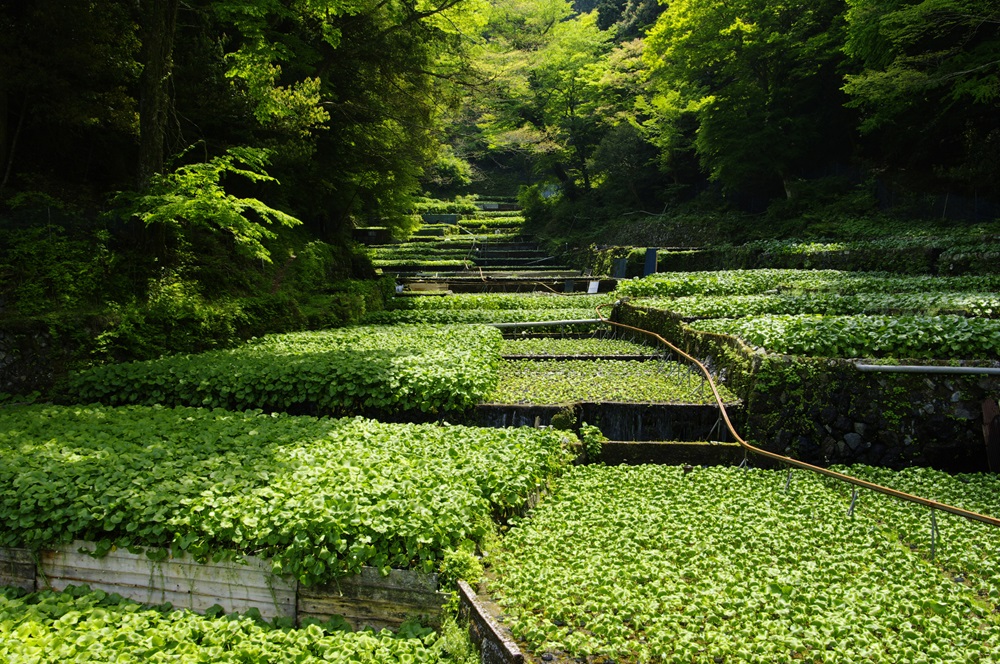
[645,0,849,197]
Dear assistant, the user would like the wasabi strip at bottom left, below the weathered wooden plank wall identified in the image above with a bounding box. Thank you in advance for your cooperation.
[0,586,468,664]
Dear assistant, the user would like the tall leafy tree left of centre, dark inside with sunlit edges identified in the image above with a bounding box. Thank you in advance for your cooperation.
[207,0,485,237]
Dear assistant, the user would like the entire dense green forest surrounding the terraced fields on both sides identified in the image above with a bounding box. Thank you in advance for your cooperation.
[0,0,1000,358]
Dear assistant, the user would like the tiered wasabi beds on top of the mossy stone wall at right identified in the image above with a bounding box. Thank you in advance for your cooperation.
[618,270,1000,362]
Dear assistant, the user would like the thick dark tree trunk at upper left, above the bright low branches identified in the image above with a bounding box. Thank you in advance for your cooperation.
[137,0,179,189]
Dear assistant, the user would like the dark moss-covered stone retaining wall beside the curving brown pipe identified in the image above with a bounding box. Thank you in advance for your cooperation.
[614,303,1000,471]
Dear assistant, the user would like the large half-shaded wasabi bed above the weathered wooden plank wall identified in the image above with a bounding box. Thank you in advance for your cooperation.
[0,406,571,585]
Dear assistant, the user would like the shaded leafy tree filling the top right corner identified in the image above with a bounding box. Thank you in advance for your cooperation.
[844,0,1000,195]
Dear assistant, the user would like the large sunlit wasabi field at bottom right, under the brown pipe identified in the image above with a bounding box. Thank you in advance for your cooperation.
[490,466,1000,663]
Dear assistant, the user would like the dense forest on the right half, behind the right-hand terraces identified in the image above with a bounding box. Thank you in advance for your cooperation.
[474,0,1000,235]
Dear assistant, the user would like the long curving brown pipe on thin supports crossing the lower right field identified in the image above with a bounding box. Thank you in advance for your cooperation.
[597,303,1000,526]
